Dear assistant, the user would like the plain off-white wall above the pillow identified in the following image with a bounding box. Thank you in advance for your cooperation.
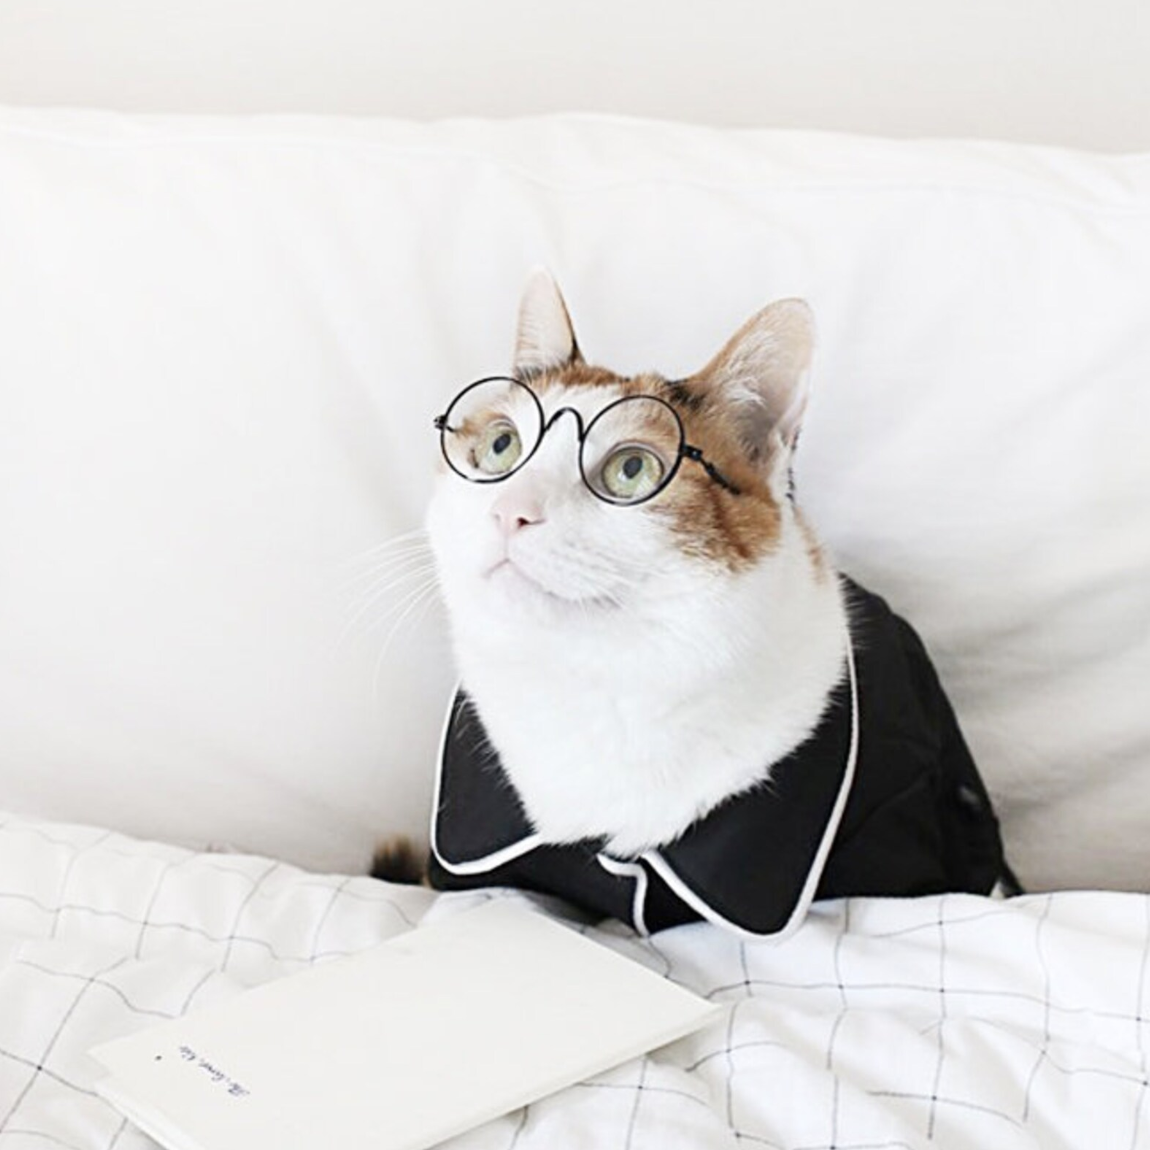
[0,0,1150,151]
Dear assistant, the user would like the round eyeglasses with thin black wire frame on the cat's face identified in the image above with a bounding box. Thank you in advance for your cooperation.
[435,376,739,507]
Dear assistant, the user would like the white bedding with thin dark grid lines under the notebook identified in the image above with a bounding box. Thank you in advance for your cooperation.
[0,817,1150,1150]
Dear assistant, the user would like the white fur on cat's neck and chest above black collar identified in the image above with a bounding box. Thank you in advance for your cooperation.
[458,552,846,856]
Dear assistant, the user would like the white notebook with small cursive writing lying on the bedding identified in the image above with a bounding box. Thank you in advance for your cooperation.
[92,900,719,1150]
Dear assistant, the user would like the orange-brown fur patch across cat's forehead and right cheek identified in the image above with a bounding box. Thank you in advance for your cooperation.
[529,361,782,572]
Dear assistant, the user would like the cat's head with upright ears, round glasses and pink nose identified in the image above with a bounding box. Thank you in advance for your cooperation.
[428,271,813,633]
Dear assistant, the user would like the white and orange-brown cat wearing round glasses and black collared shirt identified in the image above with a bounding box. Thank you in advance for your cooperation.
[379,270,1003,935]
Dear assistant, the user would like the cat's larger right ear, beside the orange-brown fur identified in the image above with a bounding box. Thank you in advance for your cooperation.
[691,299,814,466]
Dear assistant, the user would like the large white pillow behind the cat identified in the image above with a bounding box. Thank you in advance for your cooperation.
[0,110,1150,888]
